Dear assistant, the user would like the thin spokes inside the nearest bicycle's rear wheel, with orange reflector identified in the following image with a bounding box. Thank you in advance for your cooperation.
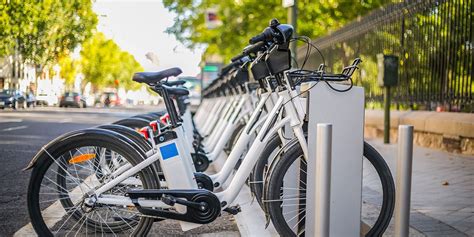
[37,143,149,236]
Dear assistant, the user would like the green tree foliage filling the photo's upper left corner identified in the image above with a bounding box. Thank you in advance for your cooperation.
[0,0,97,65]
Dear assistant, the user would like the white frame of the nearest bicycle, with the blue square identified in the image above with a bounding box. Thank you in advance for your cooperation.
[90,78,308,215]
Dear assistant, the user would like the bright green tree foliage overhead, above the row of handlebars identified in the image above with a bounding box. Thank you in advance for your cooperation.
[163,0,390,60]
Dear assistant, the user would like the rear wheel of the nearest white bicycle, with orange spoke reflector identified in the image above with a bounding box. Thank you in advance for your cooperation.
[28,133,159,236]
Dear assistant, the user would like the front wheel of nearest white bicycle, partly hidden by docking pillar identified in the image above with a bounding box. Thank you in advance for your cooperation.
[263,142,395,236]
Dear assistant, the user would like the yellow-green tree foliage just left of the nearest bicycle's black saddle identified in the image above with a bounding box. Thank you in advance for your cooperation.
[80,33,143,90]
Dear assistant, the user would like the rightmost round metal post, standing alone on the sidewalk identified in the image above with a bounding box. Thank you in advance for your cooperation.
[395,125,413,237]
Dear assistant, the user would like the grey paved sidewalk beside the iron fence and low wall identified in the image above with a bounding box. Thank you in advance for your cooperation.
[228,139,474,237]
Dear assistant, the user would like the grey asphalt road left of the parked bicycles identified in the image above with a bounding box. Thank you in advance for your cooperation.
[0,108,154,236]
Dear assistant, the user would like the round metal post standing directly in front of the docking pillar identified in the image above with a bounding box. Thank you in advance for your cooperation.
[311,123,332,237]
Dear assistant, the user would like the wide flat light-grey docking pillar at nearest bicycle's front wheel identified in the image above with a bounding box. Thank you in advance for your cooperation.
[305,82,364,237]
